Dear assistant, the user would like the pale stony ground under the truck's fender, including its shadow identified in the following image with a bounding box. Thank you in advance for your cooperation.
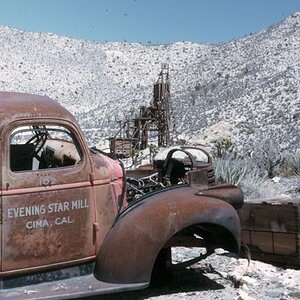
[86,248,300,300]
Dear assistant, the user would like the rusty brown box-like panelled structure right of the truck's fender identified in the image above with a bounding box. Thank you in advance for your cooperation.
[238,199,300,268]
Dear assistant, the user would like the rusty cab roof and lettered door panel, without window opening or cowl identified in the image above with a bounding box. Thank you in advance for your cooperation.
[0,93,95,276]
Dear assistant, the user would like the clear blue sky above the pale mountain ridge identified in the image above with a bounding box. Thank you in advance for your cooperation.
[0,0,300,44]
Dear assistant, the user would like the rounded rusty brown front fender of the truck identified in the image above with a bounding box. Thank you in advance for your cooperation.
[95,186,240,283]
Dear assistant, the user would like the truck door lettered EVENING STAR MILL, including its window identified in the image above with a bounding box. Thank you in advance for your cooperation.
[1,121,95,274]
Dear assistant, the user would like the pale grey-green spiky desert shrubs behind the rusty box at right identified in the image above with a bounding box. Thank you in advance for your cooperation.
[213,139,300,199]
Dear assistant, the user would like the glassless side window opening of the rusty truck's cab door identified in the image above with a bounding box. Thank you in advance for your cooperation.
[10,125,82,172]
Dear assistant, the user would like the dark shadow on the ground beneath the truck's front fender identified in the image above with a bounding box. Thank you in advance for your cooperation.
[83,269,224,300]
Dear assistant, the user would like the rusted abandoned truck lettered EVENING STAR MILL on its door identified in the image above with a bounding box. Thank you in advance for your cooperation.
[0,92,243,299]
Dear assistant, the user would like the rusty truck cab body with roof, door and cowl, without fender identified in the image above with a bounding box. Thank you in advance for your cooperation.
[0,92,124,276]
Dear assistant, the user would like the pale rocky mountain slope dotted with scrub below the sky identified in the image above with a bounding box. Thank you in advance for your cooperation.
[0,13,300,151]
